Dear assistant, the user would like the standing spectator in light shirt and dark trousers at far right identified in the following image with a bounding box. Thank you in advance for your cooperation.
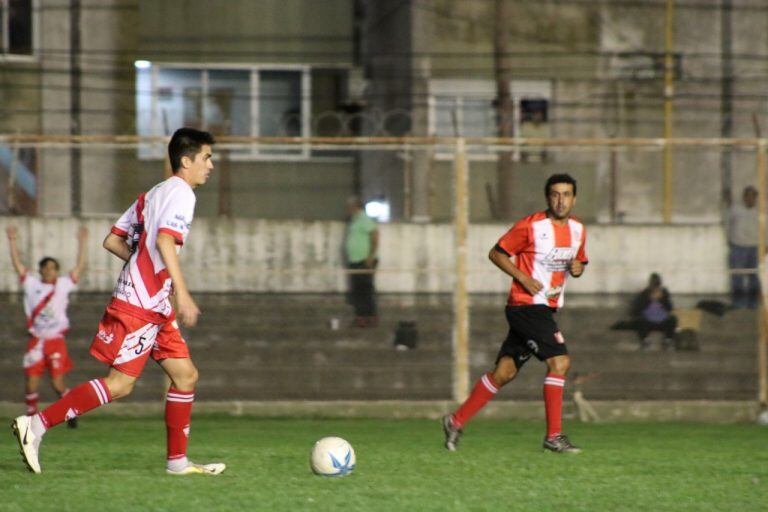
[728,186,760,309]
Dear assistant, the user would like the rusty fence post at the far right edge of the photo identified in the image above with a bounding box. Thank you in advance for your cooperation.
[757,139,768,407]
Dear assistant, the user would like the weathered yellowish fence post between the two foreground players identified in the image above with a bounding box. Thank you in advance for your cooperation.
[453,138,469,402]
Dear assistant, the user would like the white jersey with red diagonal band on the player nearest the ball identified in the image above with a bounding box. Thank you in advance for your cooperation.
[111,176,196,323]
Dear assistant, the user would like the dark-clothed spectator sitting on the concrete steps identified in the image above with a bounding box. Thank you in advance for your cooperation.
[632,272,677,350]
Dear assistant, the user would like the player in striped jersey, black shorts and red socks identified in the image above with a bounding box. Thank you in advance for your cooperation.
[443,174,587,453]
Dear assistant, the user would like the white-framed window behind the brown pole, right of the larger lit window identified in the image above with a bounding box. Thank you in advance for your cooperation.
[429,79,552,159]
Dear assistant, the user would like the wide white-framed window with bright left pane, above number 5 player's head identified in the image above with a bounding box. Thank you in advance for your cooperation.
[135,61,346,158]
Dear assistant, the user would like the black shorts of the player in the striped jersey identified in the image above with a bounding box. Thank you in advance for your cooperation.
[496,304,568,370]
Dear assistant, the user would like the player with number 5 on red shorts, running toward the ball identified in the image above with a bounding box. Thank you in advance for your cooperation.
[13,128,226,475]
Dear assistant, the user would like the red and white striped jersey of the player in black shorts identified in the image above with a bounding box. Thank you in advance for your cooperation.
[497,212,588,308]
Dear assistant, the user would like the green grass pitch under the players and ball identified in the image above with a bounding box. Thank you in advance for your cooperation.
[0,415,768,512]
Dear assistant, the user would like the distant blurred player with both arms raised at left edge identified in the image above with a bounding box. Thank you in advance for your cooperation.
[6,226,88,428]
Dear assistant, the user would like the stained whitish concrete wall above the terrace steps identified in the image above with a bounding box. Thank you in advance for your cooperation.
[0,217,728,294]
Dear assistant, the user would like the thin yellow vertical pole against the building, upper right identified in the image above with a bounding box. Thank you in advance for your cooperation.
[663,0,675,224]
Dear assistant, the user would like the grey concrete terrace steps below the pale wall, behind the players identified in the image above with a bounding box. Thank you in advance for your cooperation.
[0,294,757,401]
